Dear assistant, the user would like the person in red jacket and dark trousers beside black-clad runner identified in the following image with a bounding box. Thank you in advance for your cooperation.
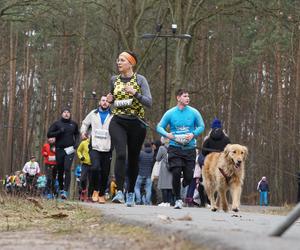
[42,137,57,199]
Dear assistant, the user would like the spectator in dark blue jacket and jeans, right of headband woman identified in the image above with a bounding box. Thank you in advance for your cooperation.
[134,142,153,205]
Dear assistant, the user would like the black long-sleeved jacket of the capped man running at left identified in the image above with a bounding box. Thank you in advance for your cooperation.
[47,118,79,148]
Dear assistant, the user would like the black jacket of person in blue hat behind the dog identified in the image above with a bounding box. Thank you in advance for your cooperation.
[202,128,230,156]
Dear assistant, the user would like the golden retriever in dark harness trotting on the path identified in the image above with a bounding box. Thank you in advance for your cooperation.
[202,144,248,212]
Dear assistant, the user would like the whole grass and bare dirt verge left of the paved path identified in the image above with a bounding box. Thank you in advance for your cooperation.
[0,197,205,250]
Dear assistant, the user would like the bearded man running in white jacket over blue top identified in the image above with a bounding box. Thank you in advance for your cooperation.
[80,96,113,204]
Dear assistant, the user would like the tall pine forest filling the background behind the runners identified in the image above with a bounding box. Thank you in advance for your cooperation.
[0,0,300,204]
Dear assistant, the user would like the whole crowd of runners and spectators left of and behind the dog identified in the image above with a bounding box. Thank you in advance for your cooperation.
[1,51,266,209]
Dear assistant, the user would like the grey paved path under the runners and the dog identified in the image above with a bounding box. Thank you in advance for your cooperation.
[82,203,300,250]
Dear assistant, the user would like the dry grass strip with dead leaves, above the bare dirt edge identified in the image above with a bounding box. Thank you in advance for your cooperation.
[0,196,205,250]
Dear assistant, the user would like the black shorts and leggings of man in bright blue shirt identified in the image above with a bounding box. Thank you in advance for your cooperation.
[168,146,196,200]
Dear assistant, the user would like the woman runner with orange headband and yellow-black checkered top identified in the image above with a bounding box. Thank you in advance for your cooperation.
[107,52,152,207]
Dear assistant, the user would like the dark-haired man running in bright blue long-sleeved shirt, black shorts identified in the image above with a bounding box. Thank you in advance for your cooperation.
[156,89,205,209]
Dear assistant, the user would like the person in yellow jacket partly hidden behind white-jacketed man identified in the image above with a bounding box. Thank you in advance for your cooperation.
[77,138,93,201]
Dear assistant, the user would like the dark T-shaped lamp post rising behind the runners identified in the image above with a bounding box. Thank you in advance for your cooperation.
[142,24,192,111]
